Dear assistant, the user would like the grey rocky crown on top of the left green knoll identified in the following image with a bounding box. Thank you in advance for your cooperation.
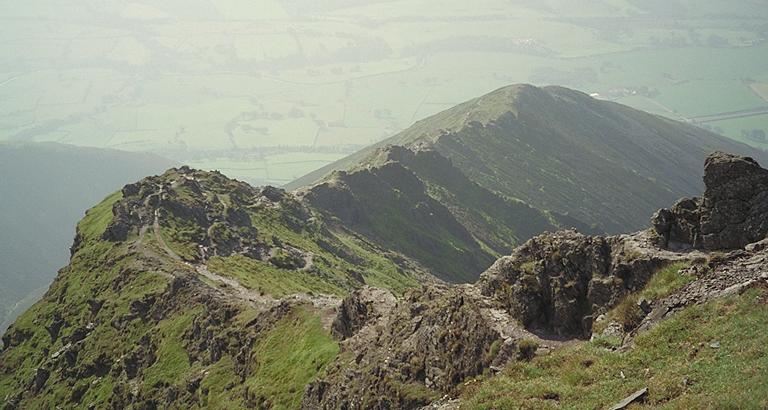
[98,167,324,270]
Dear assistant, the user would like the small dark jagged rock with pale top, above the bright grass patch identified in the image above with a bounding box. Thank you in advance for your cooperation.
[331,287,397,340]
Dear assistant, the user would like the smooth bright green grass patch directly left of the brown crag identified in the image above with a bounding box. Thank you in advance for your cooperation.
[246,308,339,409]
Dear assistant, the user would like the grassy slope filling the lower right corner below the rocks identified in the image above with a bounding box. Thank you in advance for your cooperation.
[464,289,768,409]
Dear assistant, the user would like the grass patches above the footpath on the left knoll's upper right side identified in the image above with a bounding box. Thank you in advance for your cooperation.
[156,168,418,297]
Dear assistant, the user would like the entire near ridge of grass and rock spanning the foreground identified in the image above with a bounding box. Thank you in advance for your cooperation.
[0,147,768,410]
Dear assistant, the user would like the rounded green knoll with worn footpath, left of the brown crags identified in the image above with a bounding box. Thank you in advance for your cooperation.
[0,168,420,409]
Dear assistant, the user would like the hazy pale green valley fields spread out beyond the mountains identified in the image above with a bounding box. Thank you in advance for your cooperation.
[0,0,768,184]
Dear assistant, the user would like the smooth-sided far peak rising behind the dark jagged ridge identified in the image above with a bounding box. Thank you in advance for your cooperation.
[287,85,768,233]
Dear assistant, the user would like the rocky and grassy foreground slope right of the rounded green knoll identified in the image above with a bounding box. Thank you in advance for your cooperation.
[302,154,768,409]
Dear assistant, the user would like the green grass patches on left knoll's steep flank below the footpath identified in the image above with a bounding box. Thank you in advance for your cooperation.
[0,185,344,408]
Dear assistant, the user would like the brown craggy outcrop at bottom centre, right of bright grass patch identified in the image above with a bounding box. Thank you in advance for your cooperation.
[302,286,508,409]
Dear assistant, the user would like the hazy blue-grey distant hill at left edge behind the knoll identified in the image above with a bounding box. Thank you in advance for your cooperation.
[0,143,173,332]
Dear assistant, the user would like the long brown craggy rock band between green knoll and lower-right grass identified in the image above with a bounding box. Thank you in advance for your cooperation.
[302,231,674,409]
